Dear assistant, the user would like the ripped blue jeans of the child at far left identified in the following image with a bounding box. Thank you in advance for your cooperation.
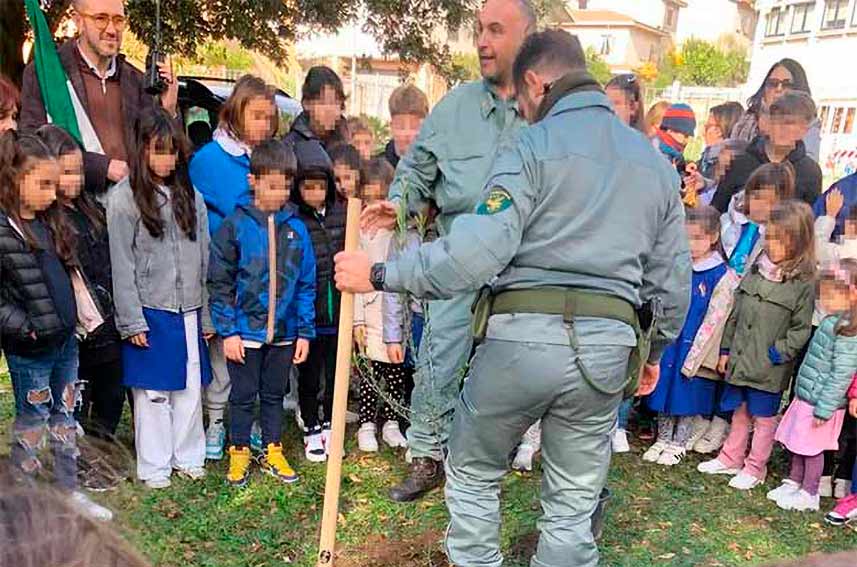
[6,335,78,490]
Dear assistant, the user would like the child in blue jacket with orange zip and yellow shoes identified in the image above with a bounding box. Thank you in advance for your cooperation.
[208,140,315,487]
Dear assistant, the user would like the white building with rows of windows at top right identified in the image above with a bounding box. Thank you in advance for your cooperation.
[746,0,857,176]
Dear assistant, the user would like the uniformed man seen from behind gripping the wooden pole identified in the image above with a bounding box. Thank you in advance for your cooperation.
[336,31,691,567]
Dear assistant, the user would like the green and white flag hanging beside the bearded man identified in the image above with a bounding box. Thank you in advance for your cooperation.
[24,0,104,154]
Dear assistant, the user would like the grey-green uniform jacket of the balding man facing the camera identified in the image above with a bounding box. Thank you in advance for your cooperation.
[389,81,526,234]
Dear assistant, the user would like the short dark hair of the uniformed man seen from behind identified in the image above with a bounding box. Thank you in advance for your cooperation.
[512,30,586,92]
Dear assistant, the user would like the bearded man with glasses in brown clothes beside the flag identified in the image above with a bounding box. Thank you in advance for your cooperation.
[19,0,178,193]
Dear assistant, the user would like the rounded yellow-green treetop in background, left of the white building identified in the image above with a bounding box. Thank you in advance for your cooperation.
[674,38,750,87]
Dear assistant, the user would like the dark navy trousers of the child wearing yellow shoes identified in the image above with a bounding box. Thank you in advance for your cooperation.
[226,344,296,448]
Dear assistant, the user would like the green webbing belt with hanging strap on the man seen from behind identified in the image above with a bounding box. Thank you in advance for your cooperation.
[489,288,643,396]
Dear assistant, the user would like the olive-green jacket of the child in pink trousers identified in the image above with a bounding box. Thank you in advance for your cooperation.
[720,267,815,393]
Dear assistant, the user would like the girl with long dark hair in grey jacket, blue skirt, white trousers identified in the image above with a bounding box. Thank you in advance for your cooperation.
[107,109,212,488]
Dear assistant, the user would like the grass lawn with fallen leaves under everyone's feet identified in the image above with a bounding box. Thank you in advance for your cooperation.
[0,368,857,567]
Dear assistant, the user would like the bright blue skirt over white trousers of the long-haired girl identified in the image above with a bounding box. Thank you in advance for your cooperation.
[122,307,211,391]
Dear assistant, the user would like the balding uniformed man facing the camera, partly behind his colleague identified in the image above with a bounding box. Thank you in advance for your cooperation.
[364,0,536,502]
